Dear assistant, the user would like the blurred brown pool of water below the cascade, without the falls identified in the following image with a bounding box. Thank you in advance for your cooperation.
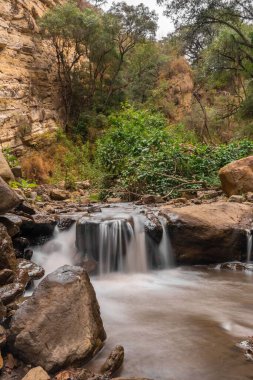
[90,268,253,380]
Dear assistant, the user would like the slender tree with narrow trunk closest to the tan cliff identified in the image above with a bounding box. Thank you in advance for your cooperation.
[40,2,99,126]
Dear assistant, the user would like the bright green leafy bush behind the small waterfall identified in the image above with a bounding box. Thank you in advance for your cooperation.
[97,107,253,196]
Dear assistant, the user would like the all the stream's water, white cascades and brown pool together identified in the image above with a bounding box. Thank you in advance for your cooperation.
[34,205,253,380]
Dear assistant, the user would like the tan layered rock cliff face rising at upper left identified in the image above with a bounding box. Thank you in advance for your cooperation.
[0,0,64,147]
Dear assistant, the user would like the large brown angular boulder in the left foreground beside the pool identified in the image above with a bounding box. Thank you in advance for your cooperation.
[9,266,106,372]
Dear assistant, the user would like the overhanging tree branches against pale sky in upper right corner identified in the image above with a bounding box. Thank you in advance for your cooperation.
[157,0,253,67]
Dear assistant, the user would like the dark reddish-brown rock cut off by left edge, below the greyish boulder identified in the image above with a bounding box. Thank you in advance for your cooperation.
[0,223,17,270]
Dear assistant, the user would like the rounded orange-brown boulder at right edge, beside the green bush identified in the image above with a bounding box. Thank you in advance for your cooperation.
[219,156,253,196]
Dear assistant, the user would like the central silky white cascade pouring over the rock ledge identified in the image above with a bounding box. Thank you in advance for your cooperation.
[76,209,173,274]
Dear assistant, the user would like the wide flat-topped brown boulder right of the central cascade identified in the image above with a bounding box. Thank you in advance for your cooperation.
[161,202,253,264]
